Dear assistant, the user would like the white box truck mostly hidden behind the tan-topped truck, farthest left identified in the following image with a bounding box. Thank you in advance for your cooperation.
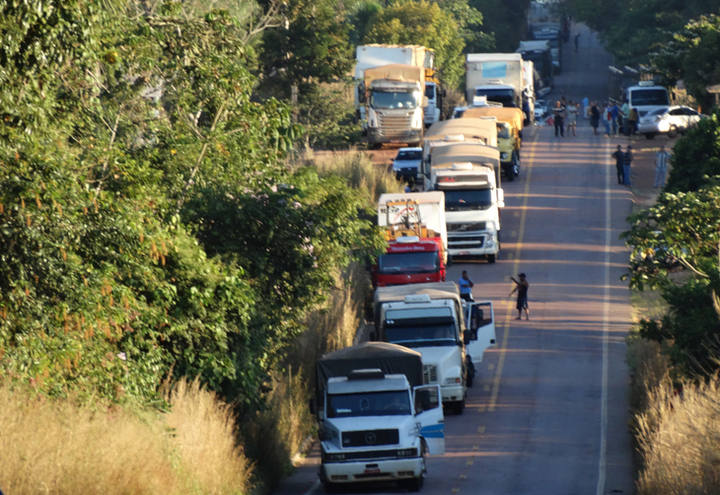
[355,44,444,141]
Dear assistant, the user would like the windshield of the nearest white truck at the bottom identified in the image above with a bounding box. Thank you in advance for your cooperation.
[327,390,411,418]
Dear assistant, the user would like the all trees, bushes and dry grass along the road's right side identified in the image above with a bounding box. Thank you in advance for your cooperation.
[567,0,720,495]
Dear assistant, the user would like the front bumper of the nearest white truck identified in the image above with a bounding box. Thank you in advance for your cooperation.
[320,457,423,483]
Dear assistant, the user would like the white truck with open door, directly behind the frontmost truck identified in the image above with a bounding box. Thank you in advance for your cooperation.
[371,282,495,414]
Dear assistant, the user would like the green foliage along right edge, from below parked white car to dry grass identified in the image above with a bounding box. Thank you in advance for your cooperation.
[624,111,720,375]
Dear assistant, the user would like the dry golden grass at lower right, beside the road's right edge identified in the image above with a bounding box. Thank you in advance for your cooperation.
[637,375,720,495]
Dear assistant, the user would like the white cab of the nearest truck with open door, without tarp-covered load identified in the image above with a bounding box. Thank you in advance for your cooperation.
[319,368,445,491]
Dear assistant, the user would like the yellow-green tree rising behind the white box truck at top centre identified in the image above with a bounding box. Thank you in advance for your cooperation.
[363,0,465,87]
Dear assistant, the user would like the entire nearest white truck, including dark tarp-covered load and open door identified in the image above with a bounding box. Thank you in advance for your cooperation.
[315,342,445,491]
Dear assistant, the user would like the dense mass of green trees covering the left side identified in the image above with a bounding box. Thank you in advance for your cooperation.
[0,0,377,407]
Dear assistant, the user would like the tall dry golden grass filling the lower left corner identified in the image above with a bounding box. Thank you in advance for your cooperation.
[0,382,251,495]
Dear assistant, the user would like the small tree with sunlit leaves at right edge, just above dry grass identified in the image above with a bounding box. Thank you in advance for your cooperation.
[623,185,720,374]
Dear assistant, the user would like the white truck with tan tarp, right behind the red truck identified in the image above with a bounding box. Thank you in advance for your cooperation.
[430,143,505,263]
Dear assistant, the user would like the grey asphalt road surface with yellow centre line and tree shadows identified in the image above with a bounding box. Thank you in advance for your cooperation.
[276,26,634,495]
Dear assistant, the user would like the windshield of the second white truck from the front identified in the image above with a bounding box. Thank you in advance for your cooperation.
[385,316,457,347]
